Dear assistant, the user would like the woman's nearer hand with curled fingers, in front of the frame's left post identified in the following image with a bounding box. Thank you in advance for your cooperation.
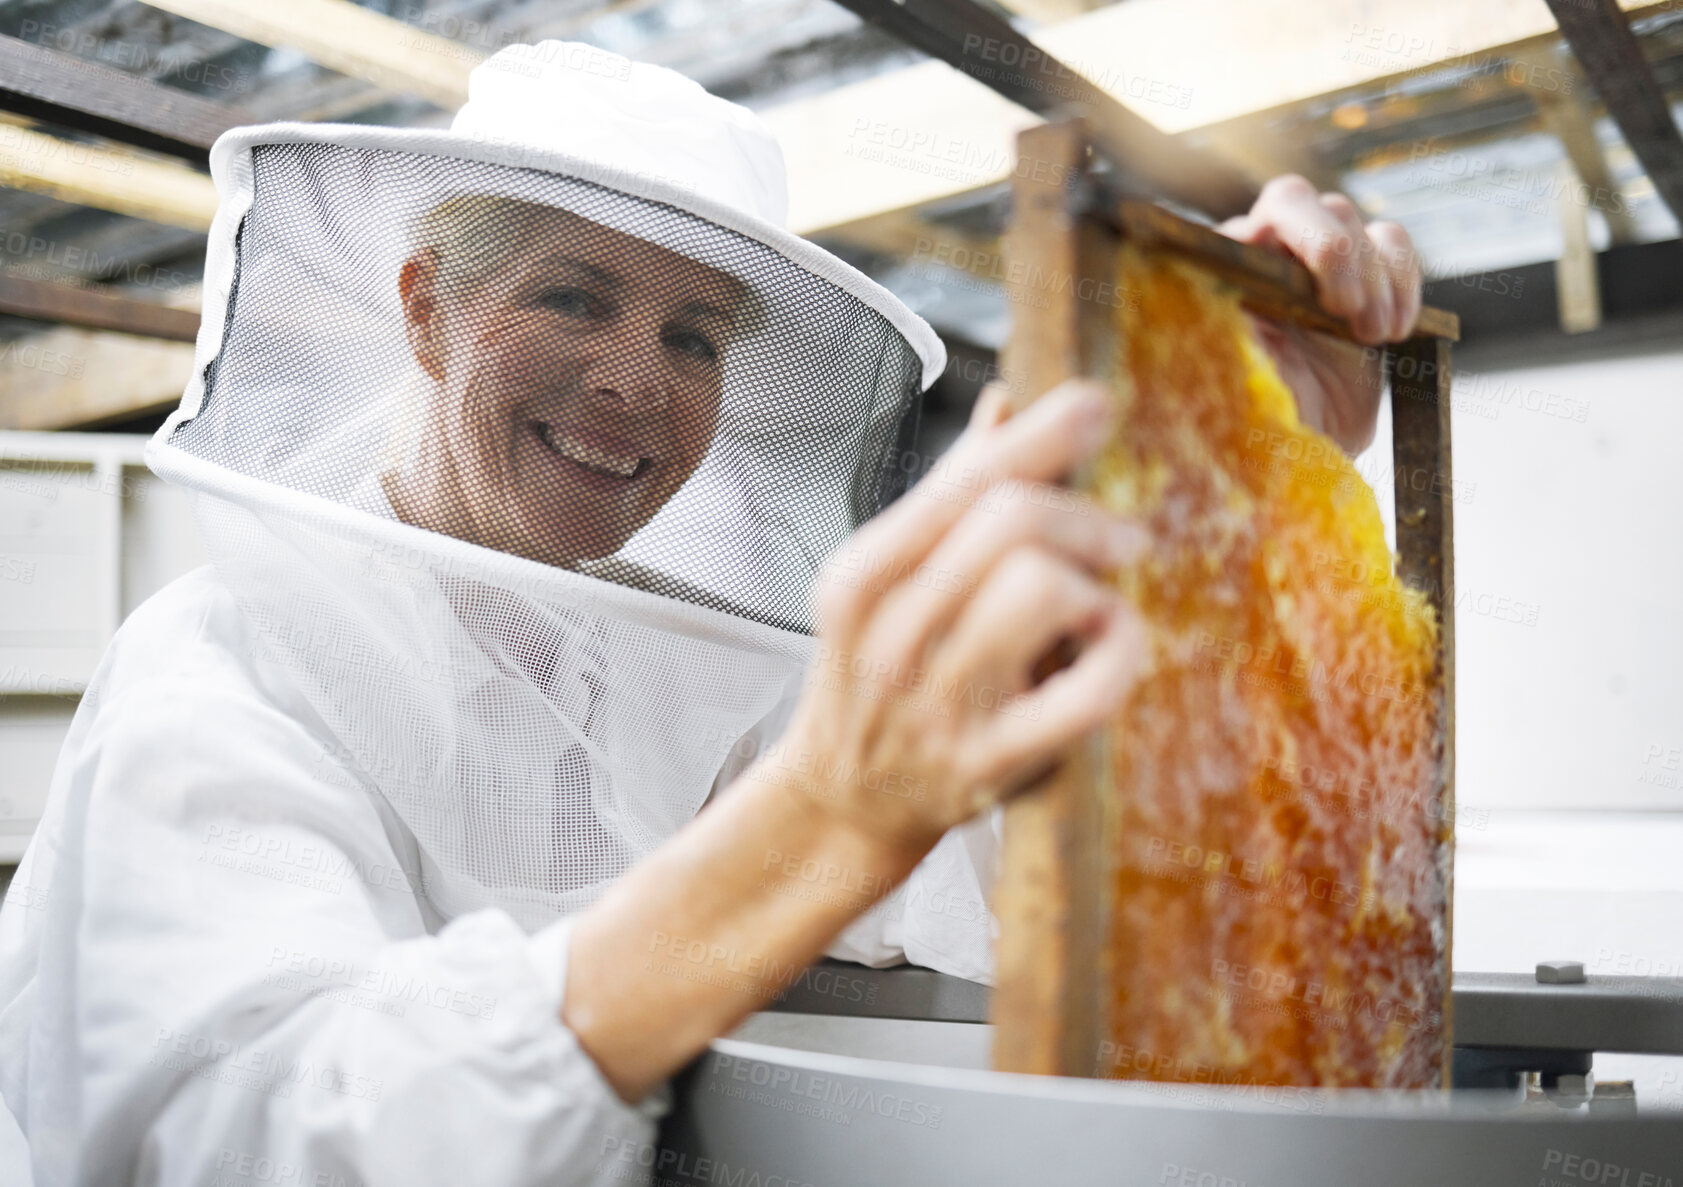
[761,381,1146,852]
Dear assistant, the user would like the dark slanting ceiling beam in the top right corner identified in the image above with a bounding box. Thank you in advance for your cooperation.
[1548,0,1683,226]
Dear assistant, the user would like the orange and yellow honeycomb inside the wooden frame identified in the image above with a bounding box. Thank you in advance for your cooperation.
[1091,246,1452,1088]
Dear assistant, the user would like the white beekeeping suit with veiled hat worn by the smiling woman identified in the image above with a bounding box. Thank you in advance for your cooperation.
[0,42,990,1187]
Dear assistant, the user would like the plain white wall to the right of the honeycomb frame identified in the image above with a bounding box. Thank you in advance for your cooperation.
[1358,338,1683,811]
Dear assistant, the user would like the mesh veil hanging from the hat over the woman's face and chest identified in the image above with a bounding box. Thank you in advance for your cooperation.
[151,141,924,928]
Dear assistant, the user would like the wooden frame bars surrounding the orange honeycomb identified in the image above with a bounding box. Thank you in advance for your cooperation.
[993,120,1459,1086]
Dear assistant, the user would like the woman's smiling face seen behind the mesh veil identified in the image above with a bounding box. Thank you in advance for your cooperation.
[387,204,747,566]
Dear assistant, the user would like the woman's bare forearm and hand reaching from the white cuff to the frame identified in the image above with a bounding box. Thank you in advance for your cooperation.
[562,372,1144,1101]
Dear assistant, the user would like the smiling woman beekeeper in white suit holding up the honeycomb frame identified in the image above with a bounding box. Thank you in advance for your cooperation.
[0,42,1419,1187]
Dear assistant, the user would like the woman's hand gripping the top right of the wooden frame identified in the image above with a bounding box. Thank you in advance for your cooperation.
[1220,173,1420,455]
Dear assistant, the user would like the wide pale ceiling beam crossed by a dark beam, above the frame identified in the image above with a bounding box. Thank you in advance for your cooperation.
[761,0,1668,234]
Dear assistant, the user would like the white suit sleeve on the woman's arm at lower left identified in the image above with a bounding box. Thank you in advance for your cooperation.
[24,639,661,1187]
